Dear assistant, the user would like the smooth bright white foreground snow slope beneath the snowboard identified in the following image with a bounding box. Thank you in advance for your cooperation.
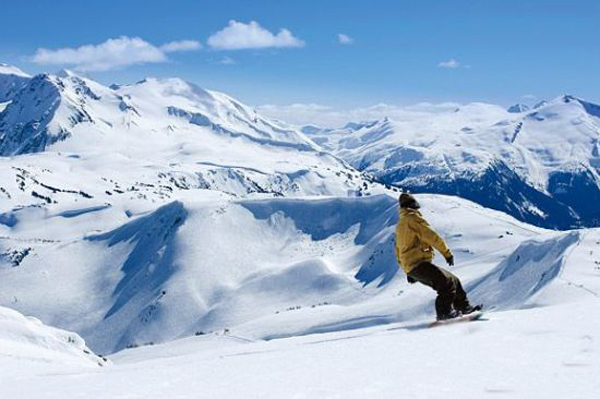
[0,306,600,399]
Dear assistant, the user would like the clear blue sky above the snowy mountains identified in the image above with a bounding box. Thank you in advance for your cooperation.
[0,0,600,120]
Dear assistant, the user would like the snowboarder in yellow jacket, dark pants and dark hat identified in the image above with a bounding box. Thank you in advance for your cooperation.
[396,193,481,320]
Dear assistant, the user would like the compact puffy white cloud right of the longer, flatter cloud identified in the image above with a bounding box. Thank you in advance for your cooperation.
[208,20,304,50]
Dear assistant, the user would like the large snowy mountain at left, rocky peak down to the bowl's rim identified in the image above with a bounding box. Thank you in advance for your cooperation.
[0,71,370,202]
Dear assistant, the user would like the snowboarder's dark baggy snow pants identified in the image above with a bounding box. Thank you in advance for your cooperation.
[408,262,469,317]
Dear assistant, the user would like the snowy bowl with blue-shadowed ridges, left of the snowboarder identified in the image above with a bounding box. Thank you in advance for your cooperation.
[0,192,395,353]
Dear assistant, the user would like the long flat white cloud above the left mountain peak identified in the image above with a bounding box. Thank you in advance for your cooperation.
[32,36,200,71]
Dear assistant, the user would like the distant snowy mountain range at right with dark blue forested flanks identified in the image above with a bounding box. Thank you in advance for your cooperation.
[303,96,600,229]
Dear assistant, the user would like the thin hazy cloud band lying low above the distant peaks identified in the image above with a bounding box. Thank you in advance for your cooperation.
[256,102,461,127]
